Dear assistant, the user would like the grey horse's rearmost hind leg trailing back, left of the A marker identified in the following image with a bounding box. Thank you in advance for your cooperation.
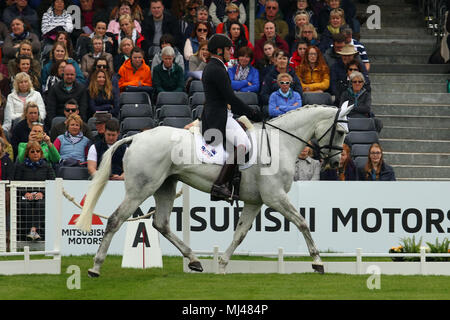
[88,196,143,277]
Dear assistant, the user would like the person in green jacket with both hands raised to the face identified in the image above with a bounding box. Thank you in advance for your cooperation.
[17,122,61,165]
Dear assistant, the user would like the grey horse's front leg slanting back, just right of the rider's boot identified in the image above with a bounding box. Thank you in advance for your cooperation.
[219,203,261,273]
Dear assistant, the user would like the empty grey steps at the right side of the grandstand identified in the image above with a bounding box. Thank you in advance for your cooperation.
[356,0,450,181]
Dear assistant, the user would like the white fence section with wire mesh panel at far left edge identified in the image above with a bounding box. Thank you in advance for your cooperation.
[0,179,62,275]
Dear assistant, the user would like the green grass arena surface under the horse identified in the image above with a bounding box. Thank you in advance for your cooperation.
[0,255,450,300]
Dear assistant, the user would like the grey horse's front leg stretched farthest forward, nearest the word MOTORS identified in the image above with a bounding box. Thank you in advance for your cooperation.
[265,194,324,273]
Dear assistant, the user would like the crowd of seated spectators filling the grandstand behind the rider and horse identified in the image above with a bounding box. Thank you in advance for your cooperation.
[0,0,398,240]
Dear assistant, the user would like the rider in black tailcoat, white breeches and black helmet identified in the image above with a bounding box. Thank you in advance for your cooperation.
[201,34,262,200]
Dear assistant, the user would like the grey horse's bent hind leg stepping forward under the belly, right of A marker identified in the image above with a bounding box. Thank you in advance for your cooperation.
[153,178,203,272]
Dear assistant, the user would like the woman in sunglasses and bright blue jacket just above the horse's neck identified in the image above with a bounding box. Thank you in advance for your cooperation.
[269,73,302,118]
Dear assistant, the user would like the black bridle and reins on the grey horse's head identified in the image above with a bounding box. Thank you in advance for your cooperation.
[262,108,348,166]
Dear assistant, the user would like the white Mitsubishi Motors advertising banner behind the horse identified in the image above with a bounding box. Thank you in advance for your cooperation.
[46,181,450,255]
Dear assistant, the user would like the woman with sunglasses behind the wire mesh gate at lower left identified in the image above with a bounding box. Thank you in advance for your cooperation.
[14,141,55,240]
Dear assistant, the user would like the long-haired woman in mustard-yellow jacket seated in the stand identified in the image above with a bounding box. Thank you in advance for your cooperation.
[295,46,330,92]
